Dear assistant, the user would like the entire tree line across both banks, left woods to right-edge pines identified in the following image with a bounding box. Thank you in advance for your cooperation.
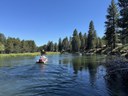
[0,0,128,53]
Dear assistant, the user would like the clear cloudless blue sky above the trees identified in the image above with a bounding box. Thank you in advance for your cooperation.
[0,0,115,46]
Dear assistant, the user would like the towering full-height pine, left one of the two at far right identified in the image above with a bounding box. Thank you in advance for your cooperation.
[105,0,119,49]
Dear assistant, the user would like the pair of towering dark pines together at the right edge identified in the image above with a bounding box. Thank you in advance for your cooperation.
[105,0,128,49]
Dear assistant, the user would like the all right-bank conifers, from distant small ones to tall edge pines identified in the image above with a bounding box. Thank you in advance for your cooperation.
[41,0,128,52]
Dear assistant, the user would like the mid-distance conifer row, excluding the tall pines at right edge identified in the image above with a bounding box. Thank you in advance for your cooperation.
[40,21,105,52]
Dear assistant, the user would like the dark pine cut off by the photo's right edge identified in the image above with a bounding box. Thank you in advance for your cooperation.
[118,0,128,44]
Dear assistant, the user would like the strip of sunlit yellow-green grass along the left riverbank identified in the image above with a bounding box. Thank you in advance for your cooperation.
[0,52,60,58]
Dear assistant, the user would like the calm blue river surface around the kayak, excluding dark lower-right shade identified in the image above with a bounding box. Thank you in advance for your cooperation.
[0,54,128,96]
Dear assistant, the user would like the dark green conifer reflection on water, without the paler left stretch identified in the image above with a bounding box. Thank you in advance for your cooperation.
[72,56,105,86]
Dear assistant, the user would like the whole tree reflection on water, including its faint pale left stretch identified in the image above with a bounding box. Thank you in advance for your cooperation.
[59,55,103,86]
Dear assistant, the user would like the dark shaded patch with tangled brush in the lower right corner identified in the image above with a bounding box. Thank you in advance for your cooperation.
[105,57,128,96]
